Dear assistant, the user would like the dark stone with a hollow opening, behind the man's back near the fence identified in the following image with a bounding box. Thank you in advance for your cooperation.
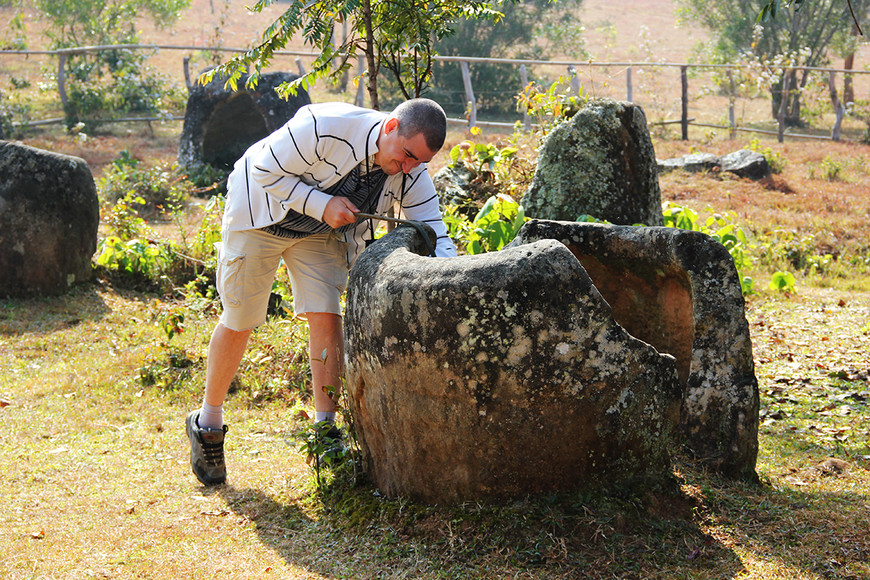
[178,72,311,169]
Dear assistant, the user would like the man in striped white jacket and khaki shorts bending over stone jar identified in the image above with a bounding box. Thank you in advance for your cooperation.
[187,99,456,485]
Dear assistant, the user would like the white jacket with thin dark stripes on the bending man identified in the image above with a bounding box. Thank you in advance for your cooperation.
[223,103,456,265]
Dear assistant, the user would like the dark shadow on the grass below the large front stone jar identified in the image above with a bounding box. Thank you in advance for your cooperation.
[219,464,743,579]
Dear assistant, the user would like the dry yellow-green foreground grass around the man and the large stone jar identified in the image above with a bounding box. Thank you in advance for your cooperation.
[0,283,870,579]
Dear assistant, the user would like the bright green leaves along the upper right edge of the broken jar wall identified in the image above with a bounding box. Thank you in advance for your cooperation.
[662,202,755,294]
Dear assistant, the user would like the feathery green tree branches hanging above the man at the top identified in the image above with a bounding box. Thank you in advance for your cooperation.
[203,0,501,109]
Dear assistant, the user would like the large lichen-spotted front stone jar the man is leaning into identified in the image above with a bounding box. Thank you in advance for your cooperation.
[346,222,680,503]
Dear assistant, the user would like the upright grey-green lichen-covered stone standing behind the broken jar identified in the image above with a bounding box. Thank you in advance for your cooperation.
[522,99,663,226]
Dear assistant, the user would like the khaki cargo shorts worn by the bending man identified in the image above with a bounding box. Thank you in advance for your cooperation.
[217,228,347,331]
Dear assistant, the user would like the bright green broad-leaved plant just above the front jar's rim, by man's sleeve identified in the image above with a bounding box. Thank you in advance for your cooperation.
[444,194,526,255]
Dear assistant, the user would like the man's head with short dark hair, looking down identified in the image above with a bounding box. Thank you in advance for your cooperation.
[375,99,447,175]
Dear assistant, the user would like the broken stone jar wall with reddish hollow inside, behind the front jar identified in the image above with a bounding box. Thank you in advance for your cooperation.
[514,220,759,479]
